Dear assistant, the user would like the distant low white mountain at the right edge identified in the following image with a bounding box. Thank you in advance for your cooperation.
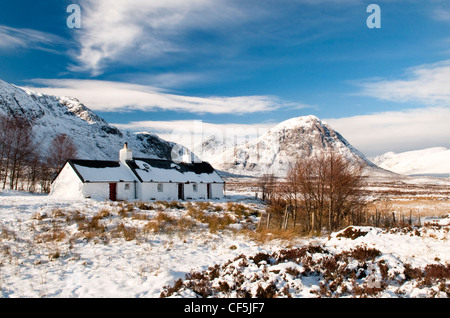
[372,147,450,177]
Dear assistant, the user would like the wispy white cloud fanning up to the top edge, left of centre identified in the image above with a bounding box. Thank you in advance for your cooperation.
[73,0,255,74]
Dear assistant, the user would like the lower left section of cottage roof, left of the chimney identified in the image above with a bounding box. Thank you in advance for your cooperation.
[68,160,138,182]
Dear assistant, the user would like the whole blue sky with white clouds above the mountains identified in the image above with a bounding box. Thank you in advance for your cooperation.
[0,0,450,156]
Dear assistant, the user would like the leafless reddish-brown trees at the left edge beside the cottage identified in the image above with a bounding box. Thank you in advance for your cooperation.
[0,114,77,192]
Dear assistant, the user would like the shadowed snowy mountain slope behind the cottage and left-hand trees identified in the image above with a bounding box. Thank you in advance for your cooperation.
[0,80,175,160]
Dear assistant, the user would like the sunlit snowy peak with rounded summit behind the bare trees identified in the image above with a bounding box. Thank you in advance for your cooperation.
[205,116,386,176]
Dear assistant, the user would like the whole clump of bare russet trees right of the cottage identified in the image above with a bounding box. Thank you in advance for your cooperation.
[260,152,365,233]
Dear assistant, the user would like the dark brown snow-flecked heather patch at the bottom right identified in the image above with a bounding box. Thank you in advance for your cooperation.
[160,244,450,298]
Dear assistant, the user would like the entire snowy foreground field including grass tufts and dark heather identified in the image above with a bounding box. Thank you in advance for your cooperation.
[0,186,450,298]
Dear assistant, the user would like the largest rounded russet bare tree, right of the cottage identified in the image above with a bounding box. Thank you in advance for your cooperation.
[282,152,364,233]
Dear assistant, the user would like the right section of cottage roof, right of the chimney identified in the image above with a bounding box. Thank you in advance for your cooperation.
[126,158,224,183]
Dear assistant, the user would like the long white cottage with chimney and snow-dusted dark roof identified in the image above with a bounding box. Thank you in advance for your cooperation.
[51,144,225,201]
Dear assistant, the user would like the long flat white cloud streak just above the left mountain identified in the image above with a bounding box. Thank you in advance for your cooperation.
[25,79,309,114]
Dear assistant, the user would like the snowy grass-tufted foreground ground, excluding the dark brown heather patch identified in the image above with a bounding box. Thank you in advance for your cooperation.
[0,191,450,298]
